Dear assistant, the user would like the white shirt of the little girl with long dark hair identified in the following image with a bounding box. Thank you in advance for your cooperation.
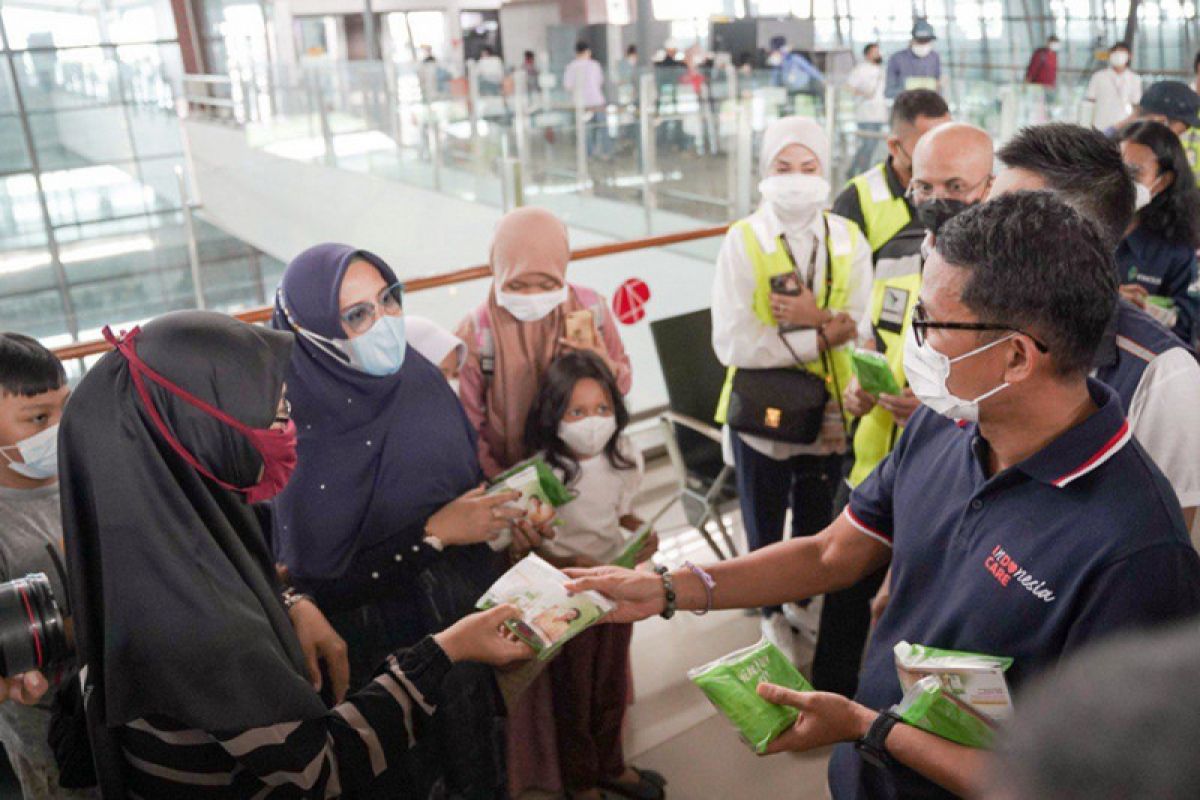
[541,437,646,564]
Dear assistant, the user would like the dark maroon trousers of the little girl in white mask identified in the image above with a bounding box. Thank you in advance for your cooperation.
[550,625,634,792]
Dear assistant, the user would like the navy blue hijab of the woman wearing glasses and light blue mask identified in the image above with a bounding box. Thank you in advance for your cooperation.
[272,243,481,585]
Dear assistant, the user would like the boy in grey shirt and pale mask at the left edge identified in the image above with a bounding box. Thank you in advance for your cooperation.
[0,333,95,800]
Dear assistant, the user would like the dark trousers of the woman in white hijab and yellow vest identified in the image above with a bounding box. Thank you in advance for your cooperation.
[731,433,842,614]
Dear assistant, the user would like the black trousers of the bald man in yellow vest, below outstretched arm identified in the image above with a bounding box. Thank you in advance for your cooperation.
[812,480,888,697]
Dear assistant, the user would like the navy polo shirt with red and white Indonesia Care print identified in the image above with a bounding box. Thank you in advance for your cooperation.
[829,380,1200,800]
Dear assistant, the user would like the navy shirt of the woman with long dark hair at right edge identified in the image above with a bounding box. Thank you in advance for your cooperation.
[1116,228,1200,344]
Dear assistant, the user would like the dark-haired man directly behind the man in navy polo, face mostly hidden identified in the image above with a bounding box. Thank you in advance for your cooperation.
[990,122,1200,528]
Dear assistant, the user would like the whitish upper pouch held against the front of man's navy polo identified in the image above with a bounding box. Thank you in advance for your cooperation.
[893,642,1013,722]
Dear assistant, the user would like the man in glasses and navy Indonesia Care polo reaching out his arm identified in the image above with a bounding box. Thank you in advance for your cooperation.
[570,192,1200,800]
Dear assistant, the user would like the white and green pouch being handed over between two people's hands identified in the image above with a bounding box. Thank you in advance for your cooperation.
[475,553,616,661]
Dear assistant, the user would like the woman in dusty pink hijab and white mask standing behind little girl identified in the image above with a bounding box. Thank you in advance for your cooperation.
[455,207,632,477]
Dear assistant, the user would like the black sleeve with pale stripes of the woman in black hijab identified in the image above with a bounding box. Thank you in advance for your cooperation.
[200,637,450,798]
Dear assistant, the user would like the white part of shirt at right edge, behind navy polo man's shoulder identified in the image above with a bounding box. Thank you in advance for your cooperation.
[1129,348,1200,509]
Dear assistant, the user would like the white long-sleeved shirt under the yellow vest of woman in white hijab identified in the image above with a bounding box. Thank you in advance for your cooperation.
[713,204,871,463]
